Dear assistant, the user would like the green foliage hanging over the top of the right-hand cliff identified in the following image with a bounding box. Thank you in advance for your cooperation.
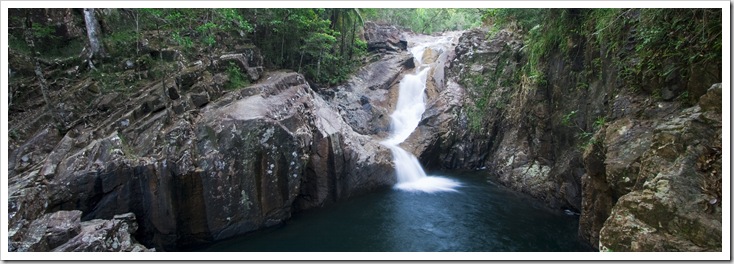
[482,8,722,101]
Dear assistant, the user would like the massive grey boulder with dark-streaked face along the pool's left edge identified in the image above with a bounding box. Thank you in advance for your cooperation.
[9,65,395,251]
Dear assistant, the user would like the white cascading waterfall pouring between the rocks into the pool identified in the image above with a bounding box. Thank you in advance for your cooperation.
[382,42,460,192]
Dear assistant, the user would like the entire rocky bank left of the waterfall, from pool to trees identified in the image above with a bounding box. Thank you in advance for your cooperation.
[8,21,413,251]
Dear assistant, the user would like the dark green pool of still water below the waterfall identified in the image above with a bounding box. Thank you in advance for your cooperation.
[200,172,592,252]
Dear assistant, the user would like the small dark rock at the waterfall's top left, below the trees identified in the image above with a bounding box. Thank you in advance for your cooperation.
[364,21,408,52]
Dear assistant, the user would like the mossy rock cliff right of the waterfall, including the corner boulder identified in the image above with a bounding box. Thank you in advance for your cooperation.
[414,25,721,251]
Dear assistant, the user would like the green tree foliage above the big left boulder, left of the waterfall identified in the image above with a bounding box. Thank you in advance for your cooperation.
[252,8,367,85]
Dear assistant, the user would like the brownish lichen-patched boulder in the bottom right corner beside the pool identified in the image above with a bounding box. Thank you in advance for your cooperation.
[599,102,722,252]
